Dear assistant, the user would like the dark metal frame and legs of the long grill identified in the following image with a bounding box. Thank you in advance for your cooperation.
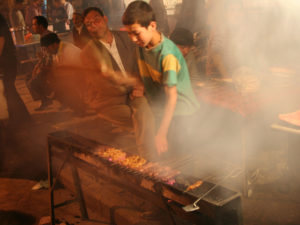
[47,131,243,225]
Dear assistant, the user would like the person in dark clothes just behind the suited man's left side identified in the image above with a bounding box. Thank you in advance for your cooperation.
[72,12,91,49]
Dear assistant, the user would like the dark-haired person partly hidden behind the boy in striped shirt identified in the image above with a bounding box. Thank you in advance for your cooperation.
[170,28,205,87]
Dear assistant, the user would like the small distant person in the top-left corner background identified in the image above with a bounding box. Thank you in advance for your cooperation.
[9,0,26,28]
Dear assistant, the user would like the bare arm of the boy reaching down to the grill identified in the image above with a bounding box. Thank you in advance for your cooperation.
[155,86,177,155]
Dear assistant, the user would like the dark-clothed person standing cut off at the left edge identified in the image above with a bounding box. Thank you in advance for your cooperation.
[0,14,31,126]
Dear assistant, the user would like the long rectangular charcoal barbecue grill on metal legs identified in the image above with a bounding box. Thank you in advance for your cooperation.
[48,131,242,225]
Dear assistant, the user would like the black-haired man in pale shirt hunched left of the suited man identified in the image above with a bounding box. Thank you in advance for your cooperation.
[41,33,84,112]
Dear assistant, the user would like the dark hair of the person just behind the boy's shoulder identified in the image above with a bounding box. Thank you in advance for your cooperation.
[170,28,194,46]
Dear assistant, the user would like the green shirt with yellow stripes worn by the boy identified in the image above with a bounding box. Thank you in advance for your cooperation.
[138,35,199,116]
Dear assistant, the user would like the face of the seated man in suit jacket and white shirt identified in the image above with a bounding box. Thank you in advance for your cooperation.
[84,11,108,39]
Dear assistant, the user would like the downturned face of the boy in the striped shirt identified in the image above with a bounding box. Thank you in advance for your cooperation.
[125,22,156,47]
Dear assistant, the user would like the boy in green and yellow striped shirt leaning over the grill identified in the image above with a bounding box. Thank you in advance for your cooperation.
[123,1,199,157]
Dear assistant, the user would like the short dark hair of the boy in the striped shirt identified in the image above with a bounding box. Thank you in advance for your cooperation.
[122,1,156,27]
